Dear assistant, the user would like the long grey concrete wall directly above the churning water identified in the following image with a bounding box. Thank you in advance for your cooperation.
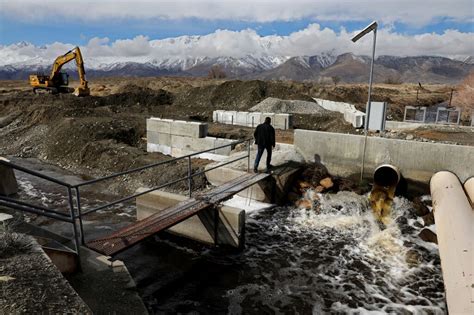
[294,129,474,182]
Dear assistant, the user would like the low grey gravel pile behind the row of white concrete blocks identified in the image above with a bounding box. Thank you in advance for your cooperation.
[250,97,329,114]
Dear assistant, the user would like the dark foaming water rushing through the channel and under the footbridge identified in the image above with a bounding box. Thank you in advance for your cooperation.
[6,159,446,314]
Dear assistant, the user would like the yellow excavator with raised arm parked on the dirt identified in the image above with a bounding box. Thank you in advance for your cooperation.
[30,47,90,96]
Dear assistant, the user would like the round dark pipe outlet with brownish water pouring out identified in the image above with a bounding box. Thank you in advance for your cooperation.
[369,164,400,225]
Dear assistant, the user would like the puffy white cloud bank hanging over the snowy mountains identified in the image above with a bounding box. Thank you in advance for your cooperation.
[0,24,474,66]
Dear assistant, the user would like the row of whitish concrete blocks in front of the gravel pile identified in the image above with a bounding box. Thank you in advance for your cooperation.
[212,110,293,130]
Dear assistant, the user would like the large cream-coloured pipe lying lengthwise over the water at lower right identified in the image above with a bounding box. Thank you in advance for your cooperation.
[430,171,474,314]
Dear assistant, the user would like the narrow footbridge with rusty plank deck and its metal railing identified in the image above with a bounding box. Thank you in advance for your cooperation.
[0,139,270,256]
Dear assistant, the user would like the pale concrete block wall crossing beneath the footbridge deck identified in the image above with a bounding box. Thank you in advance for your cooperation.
[136,188,245,247]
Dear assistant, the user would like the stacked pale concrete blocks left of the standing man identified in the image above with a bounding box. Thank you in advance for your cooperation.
[147,118,235,160]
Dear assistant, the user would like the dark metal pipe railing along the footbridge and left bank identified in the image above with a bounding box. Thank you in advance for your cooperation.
[0,139,252,256]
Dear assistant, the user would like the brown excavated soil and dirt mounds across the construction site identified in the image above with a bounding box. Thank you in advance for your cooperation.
[0,78,472,190]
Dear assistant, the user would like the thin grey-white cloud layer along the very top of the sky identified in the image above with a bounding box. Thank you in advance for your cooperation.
[0,0,474,26]
